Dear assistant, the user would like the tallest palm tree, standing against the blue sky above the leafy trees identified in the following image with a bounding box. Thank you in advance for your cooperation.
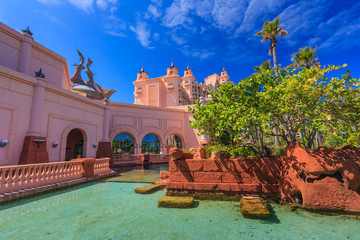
[256,16,288,68]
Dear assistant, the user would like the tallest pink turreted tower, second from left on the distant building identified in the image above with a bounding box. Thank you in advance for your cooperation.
[164,61,181,107]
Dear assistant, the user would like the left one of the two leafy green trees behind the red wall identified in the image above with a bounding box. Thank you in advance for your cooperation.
[190,72,271,157]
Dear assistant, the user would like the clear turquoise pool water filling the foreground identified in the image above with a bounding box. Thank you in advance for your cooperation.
[0,169,360,240]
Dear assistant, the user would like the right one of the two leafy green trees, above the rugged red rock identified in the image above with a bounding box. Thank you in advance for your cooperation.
[264,65,360,148]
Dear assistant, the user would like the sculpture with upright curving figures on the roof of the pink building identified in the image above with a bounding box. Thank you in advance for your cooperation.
[70,50,116,102]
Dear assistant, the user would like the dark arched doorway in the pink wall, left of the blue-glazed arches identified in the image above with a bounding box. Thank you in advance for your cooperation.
[65,128,84,161]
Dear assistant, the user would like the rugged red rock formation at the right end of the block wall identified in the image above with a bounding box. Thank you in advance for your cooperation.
[279,142,360,211]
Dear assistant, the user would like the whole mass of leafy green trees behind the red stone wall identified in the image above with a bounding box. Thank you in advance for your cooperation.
[190,65,360,154]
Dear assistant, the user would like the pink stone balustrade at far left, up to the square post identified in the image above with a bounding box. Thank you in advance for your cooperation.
[0,161,83,193]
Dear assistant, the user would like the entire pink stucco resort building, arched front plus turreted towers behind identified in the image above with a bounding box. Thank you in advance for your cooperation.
[0,23,205,166]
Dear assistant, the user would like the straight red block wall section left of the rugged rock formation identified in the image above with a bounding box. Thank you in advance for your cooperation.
[167,158,281,196]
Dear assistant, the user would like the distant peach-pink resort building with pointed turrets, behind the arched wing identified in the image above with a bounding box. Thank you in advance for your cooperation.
[134,62,230,107]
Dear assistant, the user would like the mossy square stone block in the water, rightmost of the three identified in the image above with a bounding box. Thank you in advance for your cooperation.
[240,197,270,219]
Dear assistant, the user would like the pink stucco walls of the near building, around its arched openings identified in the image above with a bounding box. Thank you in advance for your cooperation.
[0,23,200,165]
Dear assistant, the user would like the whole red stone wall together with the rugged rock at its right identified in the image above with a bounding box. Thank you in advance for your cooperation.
[167,142,360,212]
